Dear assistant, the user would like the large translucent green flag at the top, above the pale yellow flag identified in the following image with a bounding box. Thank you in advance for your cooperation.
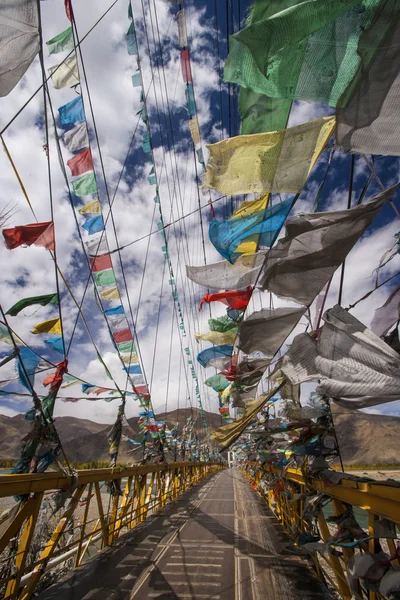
[225,0,382,133]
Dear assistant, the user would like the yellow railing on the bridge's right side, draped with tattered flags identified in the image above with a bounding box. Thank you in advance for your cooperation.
[242,466,400,600]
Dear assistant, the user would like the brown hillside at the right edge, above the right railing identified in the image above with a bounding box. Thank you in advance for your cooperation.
[332,404,400,466]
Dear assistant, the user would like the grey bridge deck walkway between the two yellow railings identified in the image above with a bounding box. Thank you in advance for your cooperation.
[39,470,330,600]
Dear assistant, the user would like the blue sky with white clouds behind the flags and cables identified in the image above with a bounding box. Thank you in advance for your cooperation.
[0,0,400,432]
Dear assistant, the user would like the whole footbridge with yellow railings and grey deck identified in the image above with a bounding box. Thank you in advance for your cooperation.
[0,463,400,600]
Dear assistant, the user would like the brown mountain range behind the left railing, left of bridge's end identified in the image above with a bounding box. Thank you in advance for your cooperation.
[0,408,221,463]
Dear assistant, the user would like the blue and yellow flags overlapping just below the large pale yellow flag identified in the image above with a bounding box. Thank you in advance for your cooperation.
[209,197,293,263]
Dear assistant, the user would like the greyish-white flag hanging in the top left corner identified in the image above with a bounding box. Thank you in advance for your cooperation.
[0,0,40,96]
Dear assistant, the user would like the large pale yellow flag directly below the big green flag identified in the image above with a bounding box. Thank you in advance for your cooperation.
[204,117,336,196]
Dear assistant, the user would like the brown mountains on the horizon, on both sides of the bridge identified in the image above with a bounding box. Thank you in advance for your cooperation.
[0,404,400,466]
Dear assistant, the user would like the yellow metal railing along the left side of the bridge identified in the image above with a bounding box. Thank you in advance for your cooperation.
[0,463,224,600]
